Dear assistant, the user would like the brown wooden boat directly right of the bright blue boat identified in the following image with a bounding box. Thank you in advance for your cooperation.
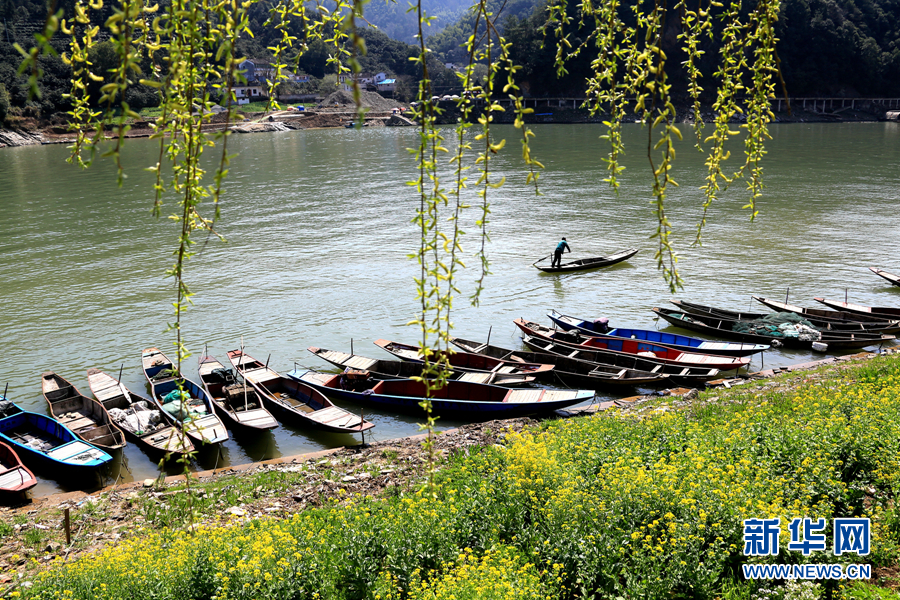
[41,371,125,452]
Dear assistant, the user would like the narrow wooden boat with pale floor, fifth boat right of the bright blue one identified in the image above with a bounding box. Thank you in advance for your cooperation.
[199,355,278,431]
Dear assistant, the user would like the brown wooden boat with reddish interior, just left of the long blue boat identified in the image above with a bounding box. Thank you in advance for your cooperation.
[228,350,375,433]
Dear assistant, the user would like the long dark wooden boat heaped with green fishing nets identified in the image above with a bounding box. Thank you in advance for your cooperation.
[652,307,894,352]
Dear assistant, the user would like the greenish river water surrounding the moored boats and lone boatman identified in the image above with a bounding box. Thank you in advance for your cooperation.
[0,123,900,495]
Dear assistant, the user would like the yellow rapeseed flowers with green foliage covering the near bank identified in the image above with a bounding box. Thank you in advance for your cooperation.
[13,357,900,600]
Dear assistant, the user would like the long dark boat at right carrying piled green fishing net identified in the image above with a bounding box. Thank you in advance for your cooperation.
[652,307,894,351]
